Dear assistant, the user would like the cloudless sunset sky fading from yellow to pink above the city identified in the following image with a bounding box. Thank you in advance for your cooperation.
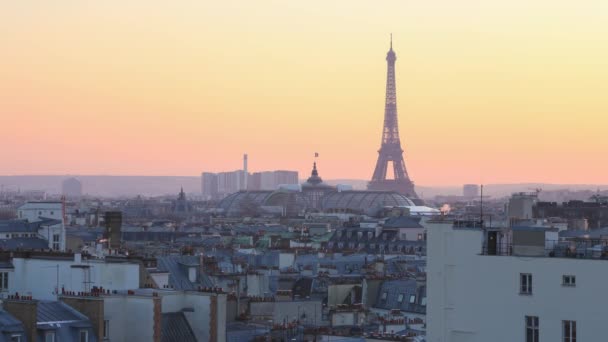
[0,0,608,185]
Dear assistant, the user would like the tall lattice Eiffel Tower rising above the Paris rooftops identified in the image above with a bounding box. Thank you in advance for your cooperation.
[367,35,418,199]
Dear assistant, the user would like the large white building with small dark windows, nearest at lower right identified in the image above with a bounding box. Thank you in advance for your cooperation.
[427,220,608,342]
